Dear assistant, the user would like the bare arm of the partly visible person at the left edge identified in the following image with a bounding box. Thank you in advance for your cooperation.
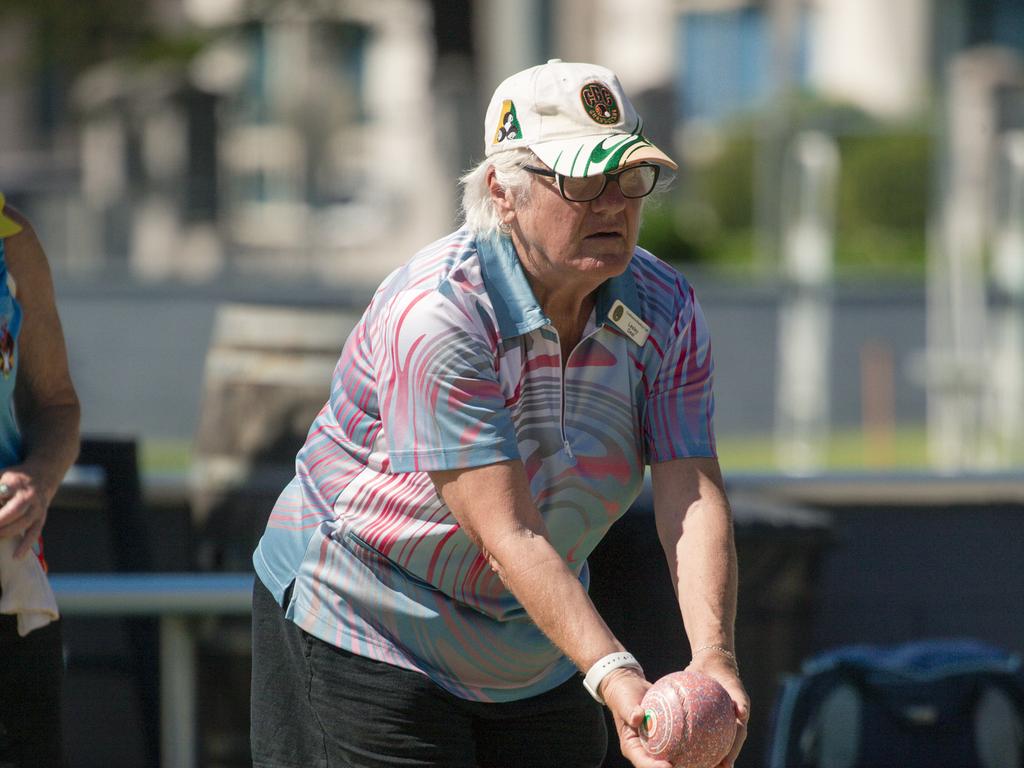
[0,208,80,557]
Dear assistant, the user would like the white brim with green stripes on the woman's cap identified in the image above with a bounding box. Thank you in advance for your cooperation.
[529,133,678,177]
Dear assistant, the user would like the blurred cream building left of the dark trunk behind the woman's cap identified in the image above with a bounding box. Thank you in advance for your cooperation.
[0,0,454,283]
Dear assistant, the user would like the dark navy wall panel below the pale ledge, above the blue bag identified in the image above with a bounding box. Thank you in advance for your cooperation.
[812,504,1024,653]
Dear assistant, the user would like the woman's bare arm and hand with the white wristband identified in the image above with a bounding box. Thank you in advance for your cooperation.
[430,461,669,768]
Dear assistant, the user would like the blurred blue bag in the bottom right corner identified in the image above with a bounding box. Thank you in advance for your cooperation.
[767,640,1024,768]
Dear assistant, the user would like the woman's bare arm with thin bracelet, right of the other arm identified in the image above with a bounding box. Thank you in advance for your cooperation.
[651,458,751,766]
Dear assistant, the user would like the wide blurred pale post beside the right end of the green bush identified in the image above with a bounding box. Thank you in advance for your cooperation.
[927,48,1024,471]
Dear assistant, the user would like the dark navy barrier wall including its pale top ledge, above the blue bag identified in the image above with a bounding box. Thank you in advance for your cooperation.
[730,473,1024,654]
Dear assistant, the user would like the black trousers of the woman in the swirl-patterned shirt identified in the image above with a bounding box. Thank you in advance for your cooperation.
[251,579,607,768]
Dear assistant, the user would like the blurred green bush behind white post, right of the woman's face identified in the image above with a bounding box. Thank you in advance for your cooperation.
[641,97,932,271]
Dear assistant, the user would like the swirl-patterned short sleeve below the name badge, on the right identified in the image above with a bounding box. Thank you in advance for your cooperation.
[643,281,716,464]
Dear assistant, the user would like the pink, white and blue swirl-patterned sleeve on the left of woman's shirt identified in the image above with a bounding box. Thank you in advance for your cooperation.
[373,290,519,472]
